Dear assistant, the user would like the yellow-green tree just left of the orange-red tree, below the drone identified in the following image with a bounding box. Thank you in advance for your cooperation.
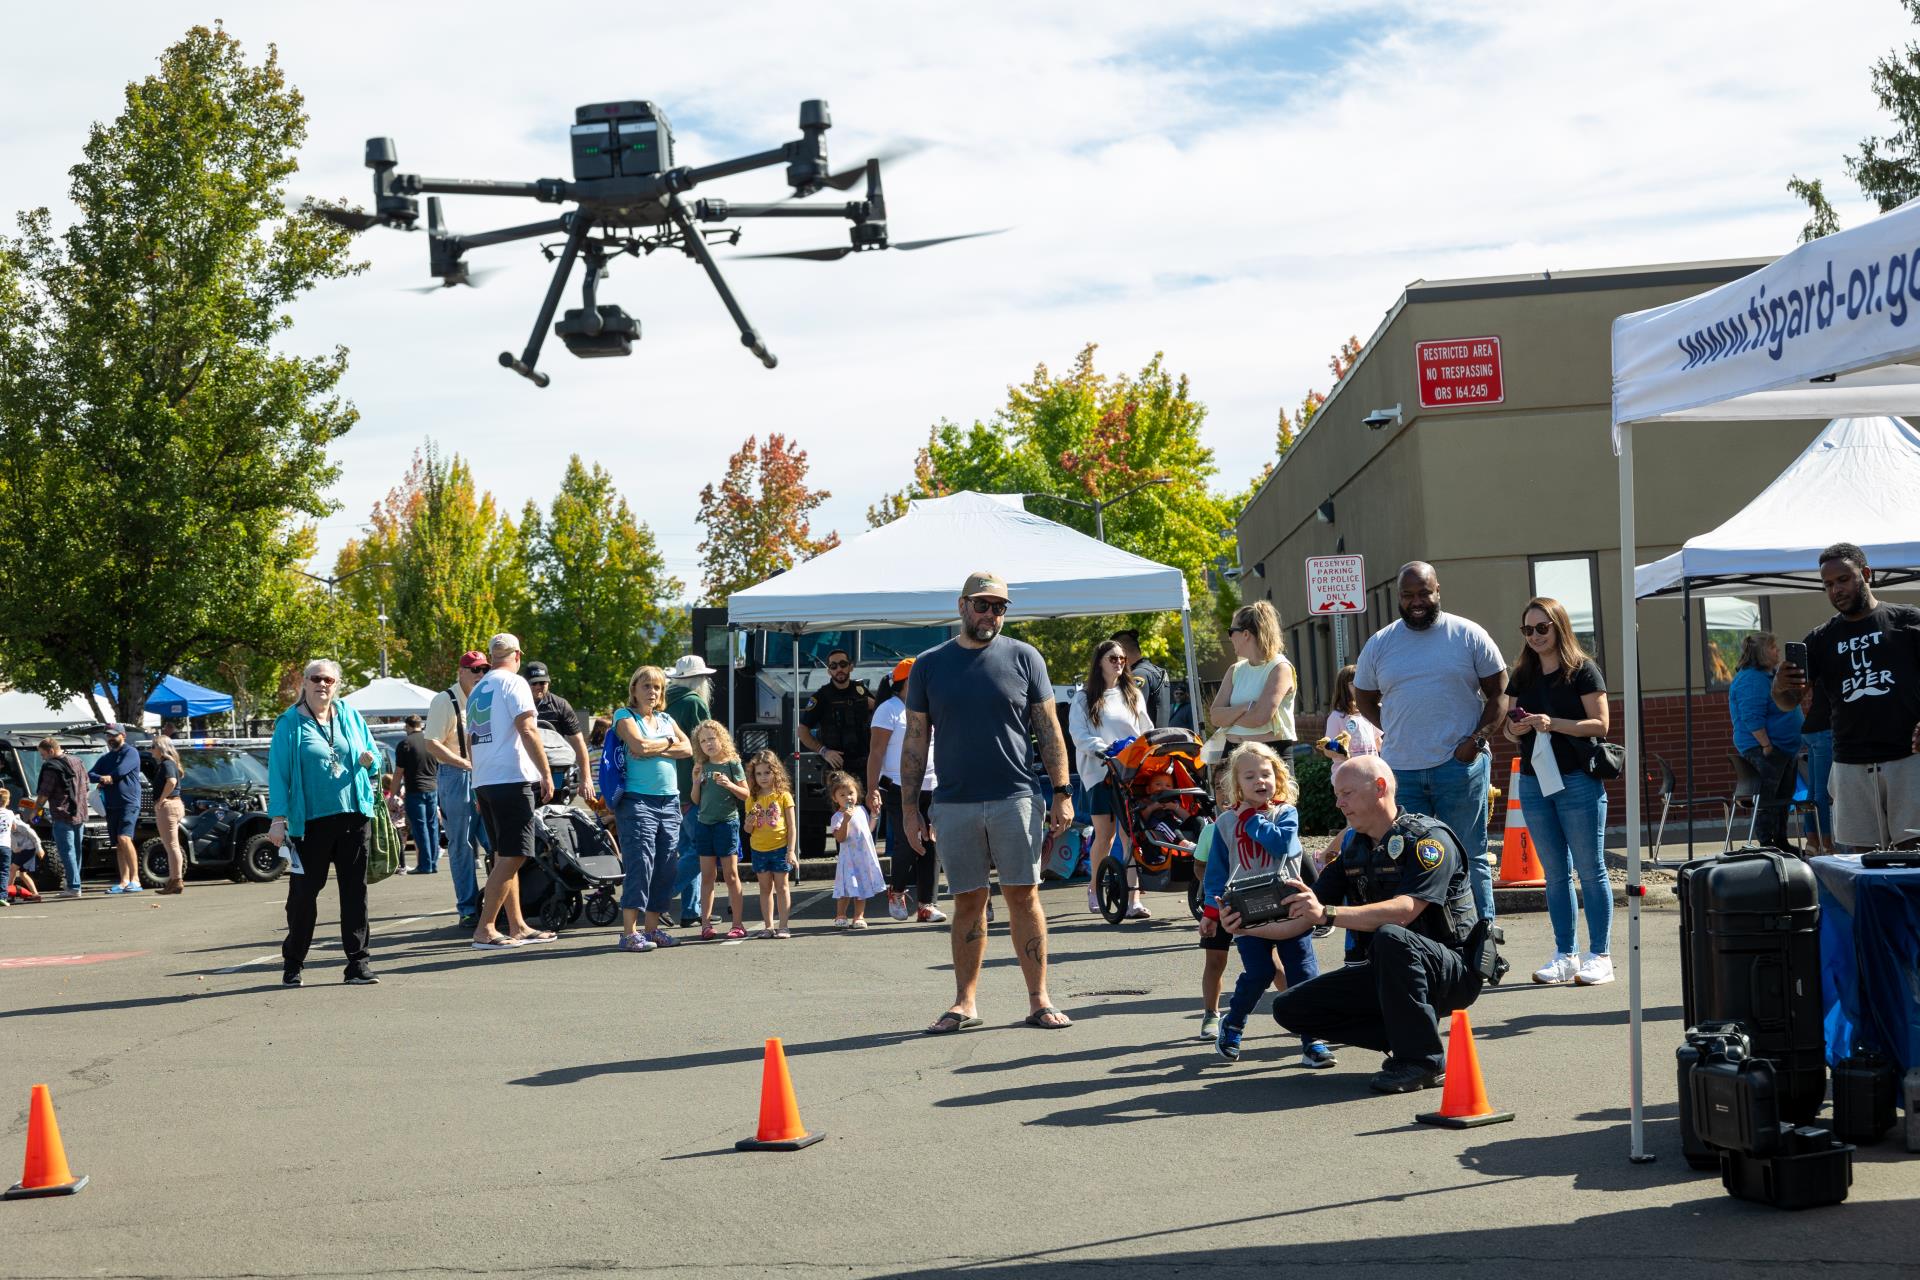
[520,453,685,710]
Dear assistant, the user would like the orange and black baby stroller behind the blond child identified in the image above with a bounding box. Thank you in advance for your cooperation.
[1094,729,1213,925]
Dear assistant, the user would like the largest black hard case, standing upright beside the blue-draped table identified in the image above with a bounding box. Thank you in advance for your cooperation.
[1678,848,1826,1125]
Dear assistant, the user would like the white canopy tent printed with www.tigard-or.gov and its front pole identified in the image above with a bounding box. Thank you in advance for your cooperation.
[1613,201,1920,1163]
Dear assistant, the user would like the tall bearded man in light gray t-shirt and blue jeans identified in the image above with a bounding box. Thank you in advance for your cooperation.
[1354,560,1507,919]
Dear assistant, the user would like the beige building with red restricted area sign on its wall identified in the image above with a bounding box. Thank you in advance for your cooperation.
[1236,259,1832,791]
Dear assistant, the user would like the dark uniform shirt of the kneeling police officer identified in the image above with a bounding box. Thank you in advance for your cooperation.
[1313,810,1478,960]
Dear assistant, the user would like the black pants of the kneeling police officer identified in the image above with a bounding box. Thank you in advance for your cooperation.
[1273,925,1480,1071]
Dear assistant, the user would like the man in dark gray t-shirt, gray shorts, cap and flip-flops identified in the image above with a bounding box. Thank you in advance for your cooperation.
[900,574,1073,1034]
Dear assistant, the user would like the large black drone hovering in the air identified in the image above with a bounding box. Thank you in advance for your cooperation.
[305,98,998,386]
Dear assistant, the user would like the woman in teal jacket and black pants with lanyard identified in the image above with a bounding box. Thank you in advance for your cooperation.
[267,658,382,986]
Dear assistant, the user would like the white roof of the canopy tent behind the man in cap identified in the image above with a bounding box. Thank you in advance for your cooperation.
[728,491,1187,631]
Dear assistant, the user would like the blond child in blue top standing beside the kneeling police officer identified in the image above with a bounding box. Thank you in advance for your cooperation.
[1200,743,1334,1069]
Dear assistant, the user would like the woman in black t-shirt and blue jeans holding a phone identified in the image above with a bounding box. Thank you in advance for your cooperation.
[1503,597,1613,986]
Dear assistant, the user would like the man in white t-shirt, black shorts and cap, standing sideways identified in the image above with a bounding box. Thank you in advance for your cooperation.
[467,631,555,952]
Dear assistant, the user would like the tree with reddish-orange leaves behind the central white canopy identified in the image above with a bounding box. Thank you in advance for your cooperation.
[695,432,839,604]
